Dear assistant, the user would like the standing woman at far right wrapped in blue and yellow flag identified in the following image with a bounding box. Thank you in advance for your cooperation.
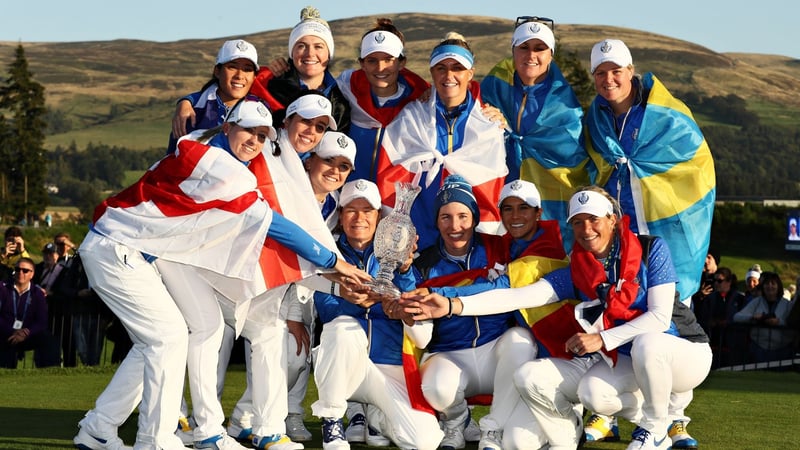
[586,39,716,306]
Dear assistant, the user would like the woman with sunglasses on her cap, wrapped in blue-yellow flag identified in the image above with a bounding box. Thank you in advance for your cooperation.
[481,16,594,245]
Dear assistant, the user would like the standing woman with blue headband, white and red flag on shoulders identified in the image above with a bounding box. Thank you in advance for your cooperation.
[376,33,508,248]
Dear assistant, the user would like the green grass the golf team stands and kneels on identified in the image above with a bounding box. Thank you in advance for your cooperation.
[0,366,800,450]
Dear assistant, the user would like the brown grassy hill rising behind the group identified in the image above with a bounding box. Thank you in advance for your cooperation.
[0,13,800,149]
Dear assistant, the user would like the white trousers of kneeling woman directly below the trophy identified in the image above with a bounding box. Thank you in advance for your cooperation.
[311,316,444,450]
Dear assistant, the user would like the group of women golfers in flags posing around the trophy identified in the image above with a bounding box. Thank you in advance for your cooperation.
[75,7,714,450]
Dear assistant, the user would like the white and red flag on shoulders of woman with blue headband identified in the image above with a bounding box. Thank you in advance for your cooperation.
[376,84,508,239]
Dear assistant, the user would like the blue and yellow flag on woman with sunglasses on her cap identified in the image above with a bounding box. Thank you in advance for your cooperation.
[481,58,595,246]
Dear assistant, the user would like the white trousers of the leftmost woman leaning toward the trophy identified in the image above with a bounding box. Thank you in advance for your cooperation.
[80,232,188,450]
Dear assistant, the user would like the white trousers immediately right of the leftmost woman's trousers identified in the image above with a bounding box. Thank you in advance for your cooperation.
[155,259,225,441]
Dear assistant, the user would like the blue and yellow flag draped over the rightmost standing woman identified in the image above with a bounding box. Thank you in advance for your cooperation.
[587,73,716,299]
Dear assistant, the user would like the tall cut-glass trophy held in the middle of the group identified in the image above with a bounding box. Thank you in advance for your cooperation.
[368,182,422,298]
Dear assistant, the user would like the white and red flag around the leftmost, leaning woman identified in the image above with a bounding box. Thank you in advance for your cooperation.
[93,139,272,295]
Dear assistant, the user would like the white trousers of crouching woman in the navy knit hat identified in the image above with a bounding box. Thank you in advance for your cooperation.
[420,327,537,431]
